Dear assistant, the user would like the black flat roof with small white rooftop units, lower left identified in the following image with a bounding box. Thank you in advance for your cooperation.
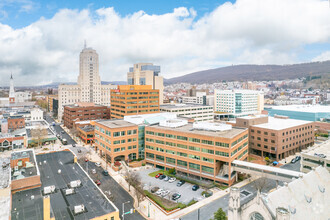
[12,151,117,220]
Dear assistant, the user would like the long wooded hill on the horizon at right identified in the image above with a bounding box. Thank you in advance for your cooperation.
[165,61,330,84]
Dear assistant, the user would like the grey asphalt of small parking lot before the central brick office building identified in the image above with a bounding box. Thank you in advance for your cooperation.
[138,168,204,204]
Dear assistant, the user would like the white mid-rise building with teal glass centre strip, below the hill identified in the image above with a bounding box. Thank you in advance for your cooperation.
[214,89,264,118]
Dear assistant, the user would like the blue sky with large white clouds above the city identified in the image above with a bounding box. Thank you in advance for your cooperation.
[0,0,330,86]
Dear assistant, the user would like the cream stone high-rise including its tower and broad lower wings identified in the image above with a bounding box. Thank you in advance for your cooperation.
[58,47,117,120]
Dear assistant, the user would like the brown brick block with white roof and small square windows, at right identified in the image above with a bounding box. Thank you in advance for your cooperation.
[236,116,314,160]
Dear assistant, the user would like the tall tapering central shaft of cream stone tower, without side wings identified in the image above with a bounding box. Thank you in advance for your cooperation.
[78,45,101,104]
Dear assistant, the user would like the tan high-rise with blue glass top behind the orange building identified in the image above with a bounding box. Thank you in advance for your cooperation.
[127,63,164,104]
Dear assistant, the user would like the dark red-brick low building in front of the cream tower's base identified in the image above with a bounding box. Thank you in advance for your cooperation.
[63,102,110,128]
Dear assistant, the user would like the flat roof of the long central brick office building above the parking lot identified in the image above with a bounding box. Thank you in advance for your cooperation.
[150,123,247,138]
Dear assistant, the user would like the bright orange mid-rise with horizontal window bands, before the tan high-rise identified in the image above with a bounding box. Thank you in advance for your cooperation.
[111,85,159,118]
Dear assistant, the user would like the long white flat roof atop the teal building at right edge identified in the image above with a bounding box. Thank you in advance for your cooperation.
[271,105,330,113]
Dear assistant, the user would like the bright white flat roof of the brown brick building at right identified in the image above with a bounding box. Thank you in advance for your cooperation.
[252,117,312,130]
